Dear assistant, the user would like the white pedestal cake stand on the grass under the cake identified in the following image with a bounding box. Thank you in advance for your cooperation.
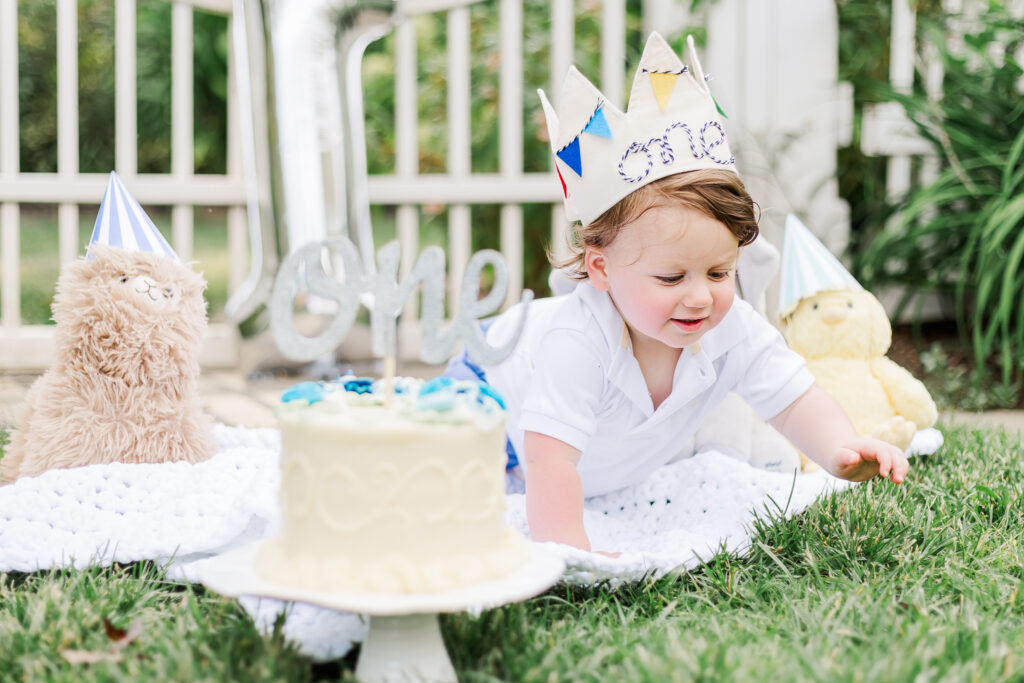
[197,542,565,683]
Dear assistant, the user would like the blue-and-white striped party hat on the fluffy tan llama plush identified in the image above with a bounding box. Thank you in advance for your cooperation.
[86,171,180,263]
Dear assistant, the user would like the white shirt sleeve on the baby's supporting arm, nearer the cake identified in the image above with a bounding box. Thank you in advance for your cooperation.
[519,329,607,451]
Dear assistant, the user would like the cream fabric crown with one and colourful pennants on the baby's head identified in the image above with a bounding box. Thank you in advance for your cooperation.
[538,33,736,224]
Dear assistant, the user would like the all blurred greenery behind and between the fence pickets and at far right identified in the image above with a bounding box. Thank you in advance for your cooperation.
[18,0,1024,407]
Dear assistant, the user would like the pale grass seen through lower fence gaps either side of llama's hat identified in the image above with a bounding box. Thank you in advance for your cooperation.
[4,207,228,325]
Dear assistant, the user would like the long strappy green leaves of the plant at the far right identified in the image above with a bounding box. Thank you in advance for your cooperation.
[861,2,1024,386]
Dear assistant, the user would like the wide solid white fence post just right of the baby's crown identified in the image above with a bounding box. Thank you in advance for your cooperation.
[703,0,850,316]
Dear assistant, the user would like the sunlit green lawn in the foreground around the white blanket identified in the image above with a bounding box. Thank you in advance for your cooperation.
[0,428,1024,683]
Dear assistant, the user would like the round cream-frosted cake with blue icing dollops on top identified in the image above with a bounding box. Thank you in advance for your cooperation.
[256,376,528,594]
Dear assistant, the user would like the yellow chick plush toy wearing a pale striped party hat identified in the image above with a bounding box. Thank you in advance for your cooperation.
[779,216,938,464]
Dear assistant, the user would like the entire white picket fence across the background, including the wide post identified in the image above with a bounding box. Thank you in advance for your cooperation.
[6,0,999,372]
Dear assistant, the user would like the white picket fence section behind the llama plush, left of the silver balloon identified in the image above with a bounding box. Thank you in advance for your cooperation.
[0,0,247,372]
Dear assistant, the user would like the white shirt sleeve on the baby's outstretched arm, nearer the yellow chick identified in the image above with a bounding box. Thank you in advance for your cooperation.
[733,313,814,420]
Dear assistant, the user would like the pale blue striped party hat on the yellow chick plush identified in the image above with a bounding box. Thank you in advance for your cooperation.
[778,213,864,317]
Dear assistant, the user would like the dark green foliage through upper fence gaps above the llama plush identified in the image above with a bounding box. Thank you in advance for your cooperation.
[17,0,227,173]
